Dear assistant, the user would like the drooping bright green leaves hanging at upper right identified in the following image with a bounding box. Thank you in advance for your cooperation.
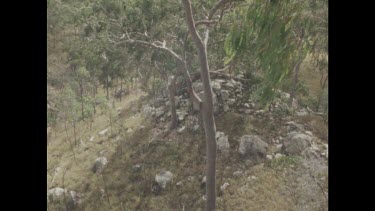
[224,0,318,106]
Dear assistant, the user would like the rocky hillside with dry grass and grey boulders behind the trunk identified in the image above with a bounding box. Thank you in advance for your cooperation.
[47,76,328,210]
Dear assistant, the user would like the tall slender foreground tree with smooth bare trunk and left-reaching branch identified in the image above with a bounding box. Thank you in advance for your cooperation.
[94,0,241,210]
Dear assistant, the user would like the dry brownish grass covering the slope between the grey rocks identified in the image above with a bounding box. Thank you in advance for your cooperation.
[47,85,328,211]
